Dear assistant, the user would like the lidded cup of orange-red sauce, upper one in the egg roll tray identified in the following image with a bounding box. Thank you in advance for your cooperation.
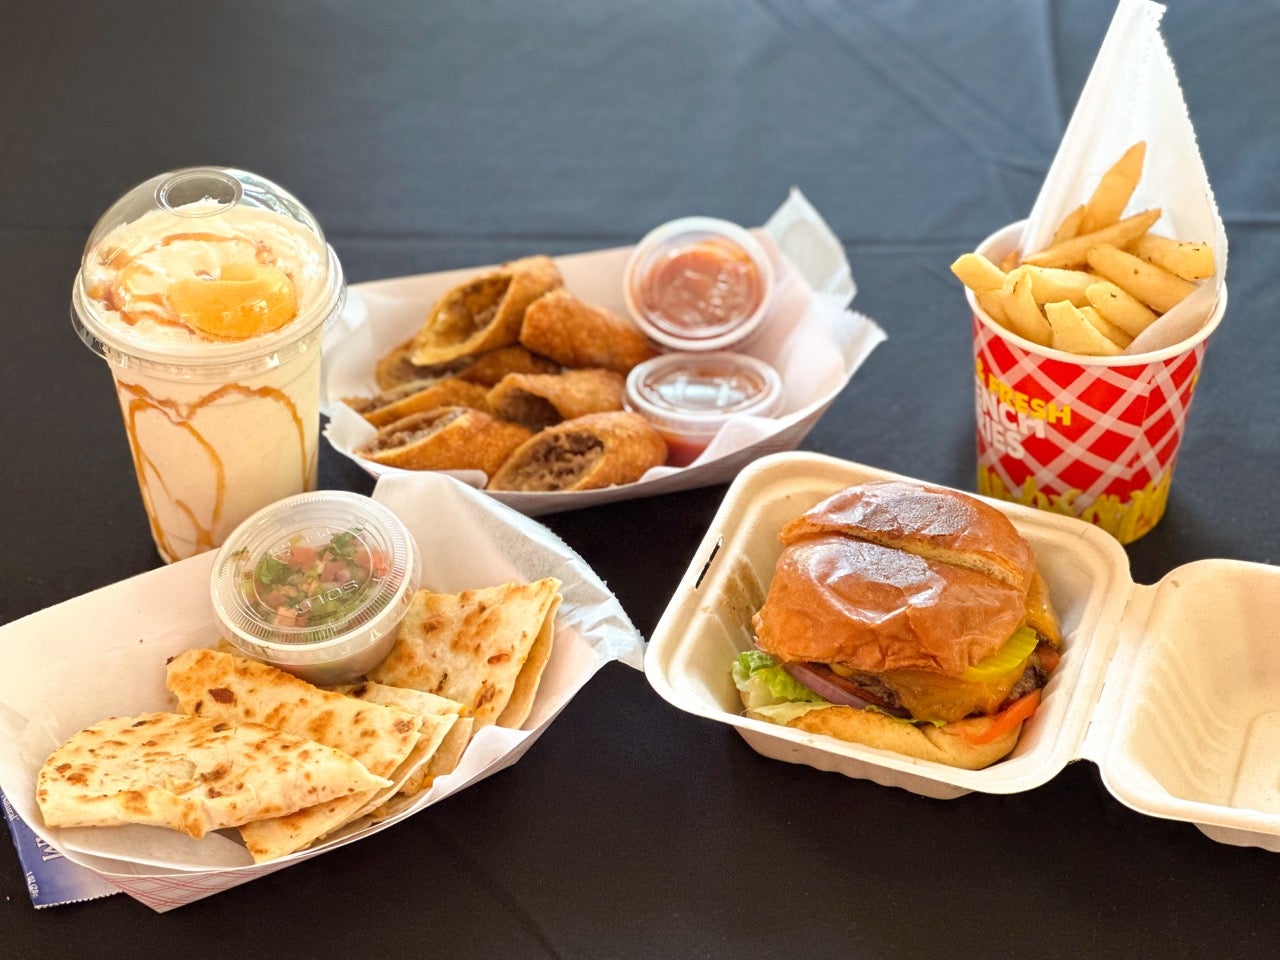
[623,216,773,351]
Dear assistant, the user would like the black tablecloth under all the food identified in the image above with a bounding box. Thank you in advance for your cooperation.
[0,0,1280,959]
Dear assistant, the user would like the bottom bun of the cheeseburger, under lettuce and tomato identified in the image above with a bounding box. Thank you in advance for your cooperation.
[746,705,1023,771]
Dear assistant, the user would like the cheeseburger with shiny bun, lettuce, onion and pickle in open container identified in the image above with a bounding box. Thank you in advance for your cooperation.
[732,481,1061,769]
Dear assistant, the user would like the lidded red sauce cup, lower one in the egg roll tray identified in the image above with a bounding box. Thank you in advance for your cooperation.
[626,351,783,466]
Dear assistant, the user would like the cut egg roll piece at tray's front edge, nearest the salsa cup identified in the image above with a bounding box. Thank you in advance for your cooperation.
[356,407,530,476]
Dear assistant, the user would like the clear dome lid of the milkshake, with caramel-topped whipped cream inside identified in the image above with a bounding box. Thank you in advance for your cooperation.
[72,166,346,372]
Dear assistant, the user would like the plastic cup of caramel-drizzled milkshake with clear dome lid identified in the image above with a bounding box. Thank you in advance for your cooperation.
[72,166,346,562]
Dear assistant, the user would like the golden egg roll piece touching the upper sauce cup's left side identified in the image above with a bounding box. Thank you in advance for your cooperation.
[520,288,658,374]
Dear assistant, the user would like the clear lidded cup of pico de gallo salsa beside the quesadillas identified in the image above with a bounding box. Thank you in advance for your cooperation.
[210,490,421,684]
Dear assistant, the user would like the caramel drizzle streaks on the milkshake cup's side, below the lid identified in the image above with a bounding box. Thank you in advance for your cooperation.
[116,381,315,559]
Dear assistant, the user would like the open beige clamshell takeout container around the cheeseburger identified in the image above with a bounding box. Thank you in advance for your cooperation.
[645,453,1280,851]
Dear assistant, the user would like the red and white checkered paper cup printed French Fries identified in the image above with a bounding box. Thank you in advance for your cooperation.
[965,223,1226,543]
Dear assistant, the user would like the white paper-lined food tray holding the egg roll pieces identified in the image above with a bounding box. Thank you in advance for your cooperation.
[321,191,884,516]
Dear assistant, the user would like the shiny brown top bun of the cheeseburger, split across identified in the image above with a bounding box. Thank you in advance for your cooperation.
[754,481,1036,676]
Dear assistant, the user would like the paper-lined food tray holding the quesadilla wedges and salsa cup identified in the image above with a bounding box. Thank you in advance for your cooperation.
[0,474,644,910]
